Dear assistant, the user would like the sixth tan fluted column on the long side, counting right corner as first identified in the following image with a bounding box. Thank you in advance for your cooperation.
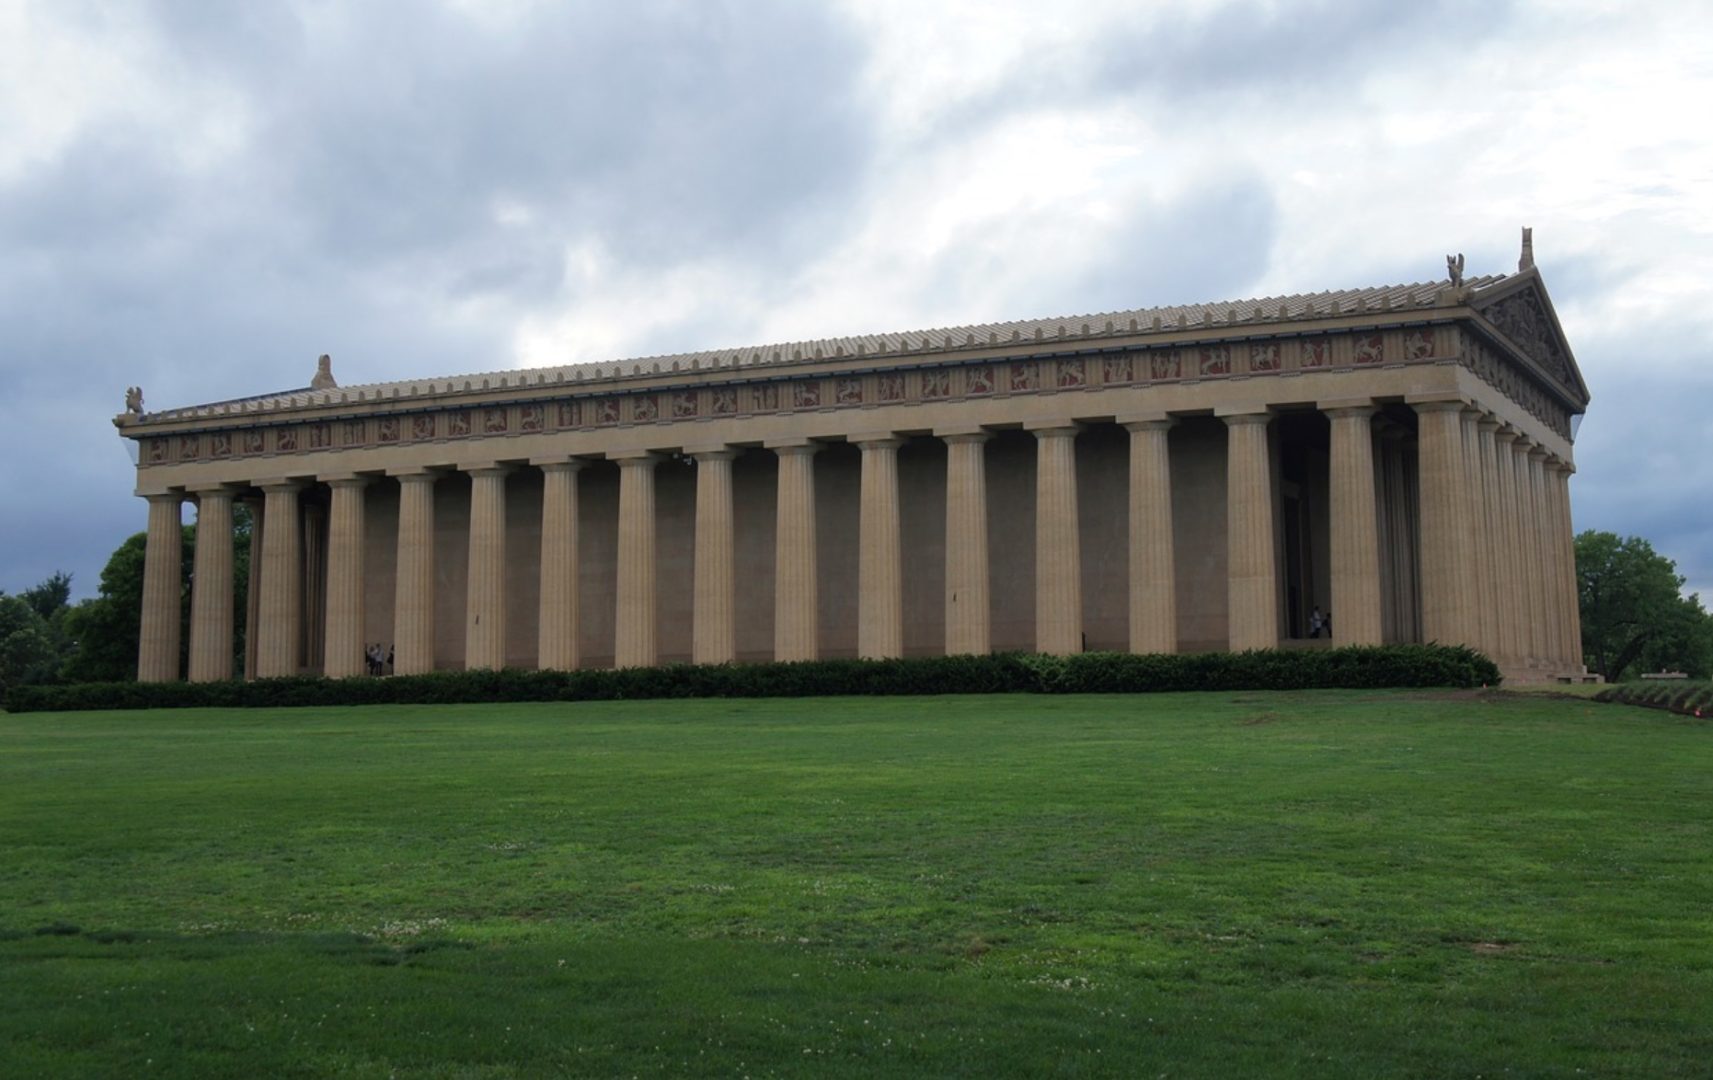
[935,430,994,657]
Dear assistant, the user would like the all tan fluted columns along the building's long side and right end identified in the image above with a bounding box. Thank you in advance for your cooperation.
[139,401,1579,681]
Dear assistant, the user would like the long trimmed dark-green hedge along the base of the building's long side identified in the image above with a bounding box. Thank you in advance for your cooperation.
[5,645,1499,713]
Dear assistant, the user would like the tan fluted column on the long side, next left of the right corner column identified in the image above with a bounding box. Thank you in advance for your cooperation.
[1322,403,1384,645]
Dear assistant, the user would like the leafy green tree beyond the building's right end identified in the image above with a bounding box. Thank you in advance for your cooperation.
[1576,530,1713,682]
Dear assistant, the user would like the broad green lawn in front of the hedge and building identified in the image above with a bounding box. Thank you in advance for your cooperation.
[0,693,1713,1077]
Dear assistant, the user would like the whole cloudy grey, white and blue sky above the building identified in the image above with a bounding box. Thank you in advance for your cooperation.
[0,0,1713,600]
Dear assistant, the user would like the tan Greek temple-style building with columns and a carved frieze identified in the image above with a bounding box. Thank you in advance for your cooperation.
[115,242,1588,681]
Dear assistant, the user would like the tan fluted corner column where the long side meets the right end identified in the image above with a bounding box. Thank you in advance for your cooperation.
[1404,401,1473,645]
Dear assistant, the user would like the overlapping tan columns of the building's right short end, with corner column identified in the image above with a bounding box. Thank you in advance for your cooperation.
[1415,399,1583,675]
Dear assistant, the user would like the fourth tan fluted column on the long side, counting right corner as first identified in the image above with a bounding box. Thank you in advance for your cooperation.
[1124,417,1177,653]
